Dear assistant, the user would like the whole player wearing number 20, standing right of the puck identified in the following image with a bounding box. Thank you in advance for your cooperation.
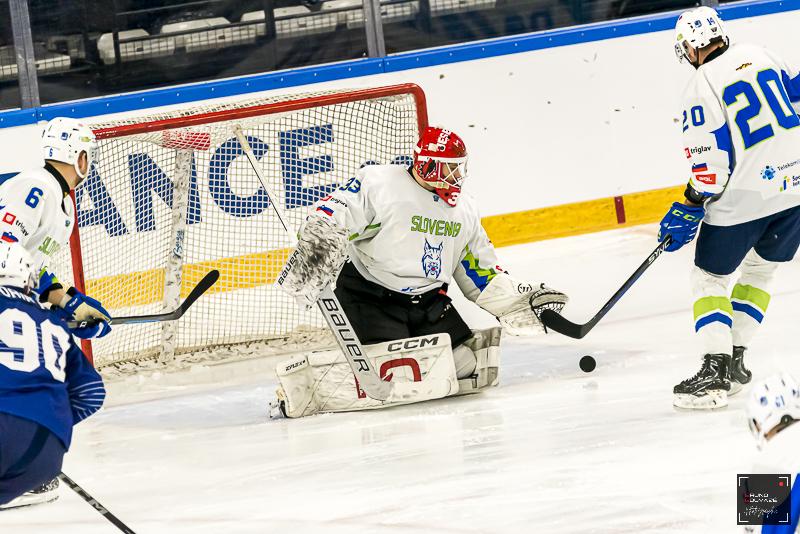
[659,7,800,409]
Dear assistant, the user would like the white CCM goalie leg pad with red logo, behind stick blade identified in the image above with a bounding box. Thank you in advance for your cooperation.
[276,334,458,418]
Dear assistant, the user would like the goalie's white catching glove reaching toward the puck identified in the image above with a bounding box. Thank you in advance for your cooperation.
[475,274,569,336]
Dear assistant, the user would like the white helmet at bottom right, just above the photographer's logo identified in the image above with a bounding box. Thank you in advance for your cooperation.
[745,373,800,446]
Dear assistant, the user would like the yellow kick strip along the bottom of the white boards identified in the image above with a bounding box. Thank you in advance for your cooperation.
[86,186,684,309]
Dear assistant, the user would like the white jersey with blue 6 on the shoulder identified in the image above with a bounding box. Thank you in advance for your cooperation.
[0,165,75,272]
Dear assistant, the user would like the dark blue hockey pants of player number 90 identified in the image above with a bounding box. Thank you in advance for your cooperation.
[0,413,67,505]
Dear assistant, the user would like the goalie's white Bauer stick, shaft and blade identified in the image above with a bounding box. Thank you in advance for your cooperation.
[234,126,392,401]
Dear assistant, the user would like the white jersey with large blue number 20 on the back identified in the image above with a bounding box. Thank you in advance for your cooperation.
[683,44,800,226]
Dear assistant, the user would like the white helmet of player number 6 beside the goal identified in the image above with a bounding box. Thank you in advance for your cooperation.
[42,117,97,180]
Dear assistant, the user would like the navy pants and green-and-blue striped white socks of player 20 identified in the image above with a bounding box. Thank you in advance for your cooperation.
[692,206,800,354]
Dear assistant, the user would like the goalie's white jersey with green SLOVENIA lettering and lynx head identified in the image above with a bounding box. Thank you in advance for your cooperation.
[313,165,503,301]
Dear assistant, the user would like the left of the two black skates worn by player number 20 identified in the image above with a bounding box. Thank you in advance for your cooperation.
[672,354,731,410]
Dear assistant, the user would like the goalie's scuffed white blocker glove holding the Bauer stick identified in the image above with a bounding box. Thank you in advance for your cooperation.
[276,215,347,309]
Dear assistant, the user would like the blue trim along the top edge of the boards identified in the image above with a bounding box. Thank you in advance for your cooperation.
[0,0,800,128]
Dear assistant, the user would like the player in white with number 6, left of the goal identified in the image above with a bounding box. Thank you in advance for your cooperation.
[0,118,111,338]
